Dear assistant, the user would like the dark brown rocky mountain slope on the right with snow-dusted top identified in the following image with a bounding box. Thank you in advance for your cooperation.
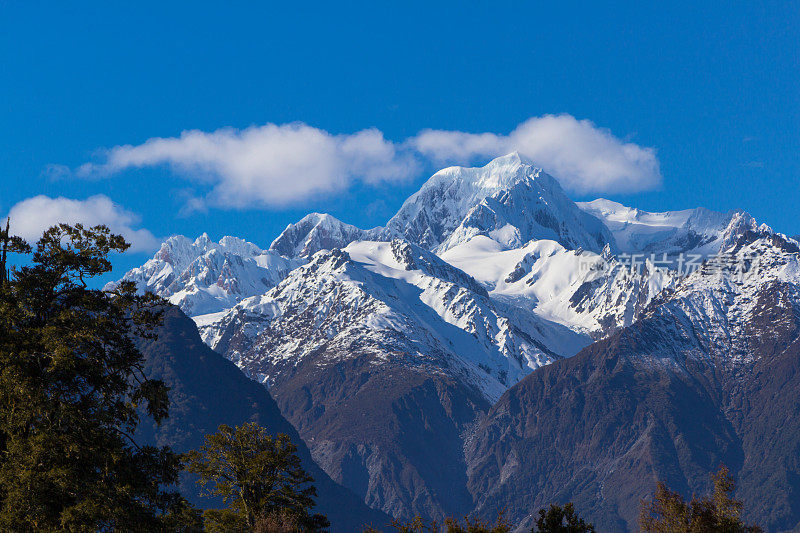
[467,231,800,531]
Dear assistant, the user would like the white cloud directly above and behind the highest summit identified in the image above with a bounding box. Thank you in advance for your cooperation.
[409,115,661,193]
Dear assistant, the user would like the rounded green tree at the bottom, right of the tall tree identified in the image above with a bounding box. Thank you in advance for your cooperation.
[185,423,329,531]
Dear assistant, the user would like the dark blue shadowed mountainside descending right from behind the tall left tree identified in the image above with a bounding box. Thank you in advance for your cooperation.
[137,307,390,532]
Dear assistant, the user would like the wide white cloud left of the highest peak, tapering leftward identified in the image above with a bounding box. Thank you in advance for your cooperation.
[78,123,416,209]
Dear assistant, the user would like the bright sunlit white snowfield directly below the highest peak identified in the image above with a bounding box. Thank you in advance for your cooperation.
[442,236,677,337]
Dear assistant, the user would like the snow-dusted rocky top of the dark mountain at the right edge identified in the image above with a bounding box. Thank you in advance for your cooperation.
[642,226,800,365]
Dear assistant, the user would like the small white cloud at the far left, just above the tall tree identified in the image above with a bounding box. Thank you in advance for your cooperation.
[3,194,159,252]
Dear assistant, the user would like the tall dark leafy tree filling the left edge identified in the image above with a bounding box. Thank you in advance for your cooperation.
[0,224,191,531]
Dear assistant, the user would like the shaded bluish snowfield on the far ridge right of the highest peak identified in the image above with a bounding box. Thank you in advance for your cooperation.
[578,198,755,256]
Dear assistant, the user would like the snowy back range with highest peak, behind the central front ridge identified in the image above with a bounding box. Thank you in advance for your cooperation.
[119,153,776,362]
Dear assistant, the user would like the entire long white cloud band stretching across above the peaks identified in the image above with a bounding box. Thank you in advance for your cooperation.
[77,115,661,209]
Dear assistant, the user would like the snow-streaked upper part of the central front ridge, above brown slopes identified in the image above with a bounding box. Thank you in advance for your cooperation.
[198,240,588,399]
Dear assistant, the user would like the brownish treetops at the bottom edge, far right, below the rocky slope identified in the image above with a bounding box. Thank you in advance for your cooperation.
[639,465,761,533]
